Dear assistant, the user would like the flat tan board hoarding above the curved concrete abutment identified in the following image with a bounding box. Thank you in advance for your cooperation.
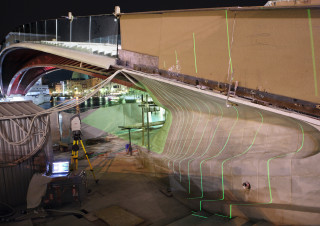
[120,8,320,103]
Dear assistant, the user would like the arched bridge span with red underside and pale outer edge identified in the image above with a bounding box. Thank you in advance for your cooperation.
[0,43,138,95]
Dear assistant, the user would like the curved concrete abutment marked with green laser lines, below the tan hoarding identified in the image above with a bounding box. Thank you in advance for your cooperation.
[128,71,320,225]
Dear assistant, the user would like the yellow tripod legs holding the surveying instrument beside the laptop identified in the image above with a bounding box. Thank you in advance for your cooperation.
[71,131,99,183]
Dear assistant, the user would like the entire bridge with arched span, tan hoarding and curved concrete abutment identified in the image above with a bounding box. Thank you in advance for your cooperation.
[0,6,320,224]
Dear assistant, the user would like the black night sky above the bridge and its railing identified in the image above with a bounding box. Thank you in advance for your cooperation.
[0,0,267,42]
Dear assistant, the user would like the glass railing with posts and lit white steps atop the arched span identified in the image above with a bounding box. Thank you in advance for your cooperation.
[1,15,121,57]
